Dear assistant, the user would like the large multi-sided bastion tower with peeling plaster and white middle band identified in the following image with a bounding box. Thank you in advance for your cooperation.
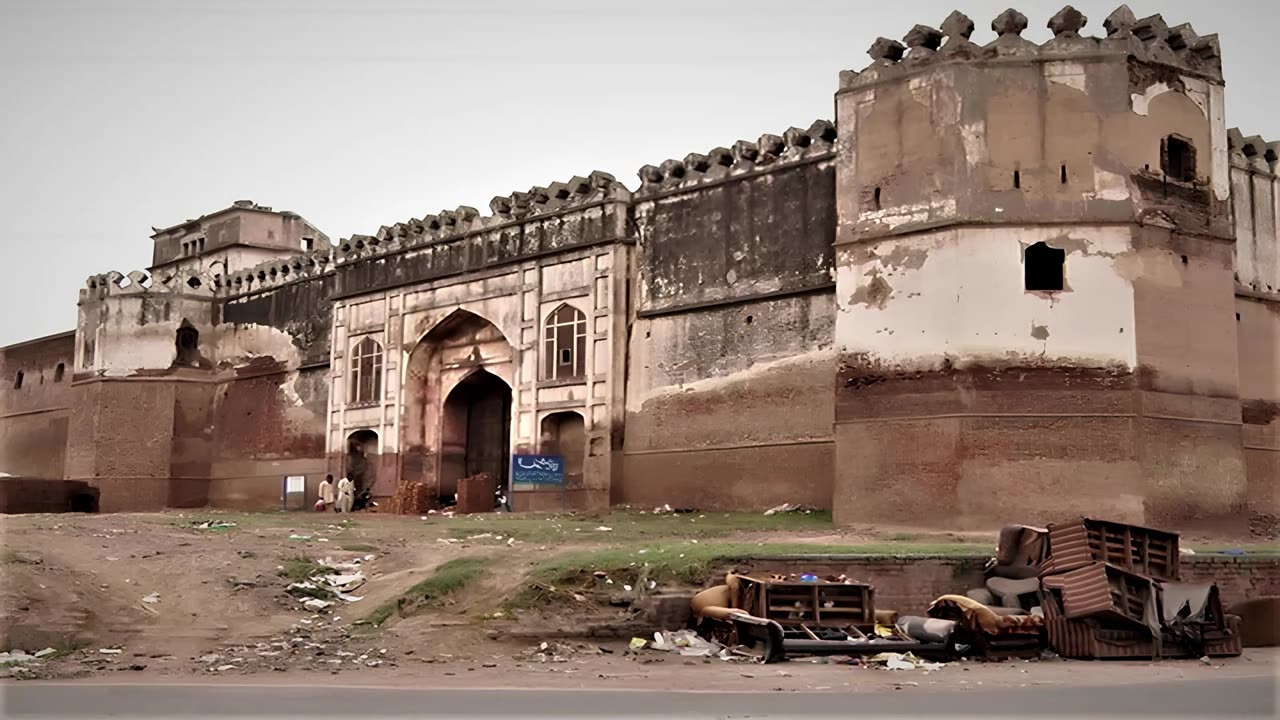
[833,6,1245,528]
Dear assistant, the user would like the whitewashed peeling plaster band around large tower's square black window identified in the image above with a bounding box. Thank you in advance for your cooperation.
[836,225,1137,372]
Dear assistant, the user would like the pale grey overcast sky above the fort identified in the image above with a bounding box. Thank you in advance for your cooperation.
[0,0,1280,345]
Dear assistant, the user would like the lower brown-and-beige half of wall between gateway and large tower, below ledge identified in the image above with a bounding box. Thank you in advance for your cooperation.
[614,292,835,510]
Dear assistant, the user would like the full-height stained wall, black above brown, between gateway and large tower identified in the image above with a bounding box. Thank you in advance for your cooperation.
[627,154,835,510]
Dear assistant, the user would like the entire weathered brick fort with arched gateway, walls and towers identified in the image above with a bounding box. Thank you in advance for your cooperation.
[0,6,1280,528]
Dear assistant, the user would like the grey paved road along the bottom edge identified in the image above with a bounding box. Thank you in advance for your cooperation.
[0,678,1277,720]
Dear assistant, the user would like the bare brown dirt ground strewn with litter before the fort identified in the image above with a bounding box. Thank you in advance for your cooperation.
[0,511,1275,691]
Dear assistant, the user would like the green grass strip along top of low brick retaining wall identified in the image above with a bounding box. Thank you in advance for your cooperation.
[504,542,982,610]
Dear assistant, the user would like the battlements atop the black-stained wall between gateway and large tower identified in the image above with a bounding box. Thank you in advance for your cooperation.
[636,120,836,197]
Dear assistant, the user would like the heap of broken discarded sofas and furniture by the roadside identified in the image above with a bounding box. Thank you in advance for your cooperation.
[691,518,1242,662]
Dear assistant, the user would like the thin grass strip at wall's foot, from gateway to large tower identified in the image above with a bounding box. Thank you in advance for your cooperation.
[448,510,832,543]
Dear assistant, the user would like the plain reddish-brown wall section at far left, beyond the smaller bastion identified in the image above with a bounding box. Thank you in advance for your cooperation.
[0,333,76,479]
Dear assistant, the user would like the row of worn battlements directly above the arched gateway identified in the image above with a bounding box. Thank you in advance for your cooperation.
[334,170,631,265]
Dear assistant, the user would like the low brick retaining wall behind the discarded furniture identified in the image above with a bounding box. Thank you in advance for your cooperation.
[732,555,1280,615]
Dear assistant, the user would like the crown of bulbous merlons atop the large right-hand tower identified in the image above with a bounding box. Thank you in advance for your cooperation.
[840,5,1222,90]
